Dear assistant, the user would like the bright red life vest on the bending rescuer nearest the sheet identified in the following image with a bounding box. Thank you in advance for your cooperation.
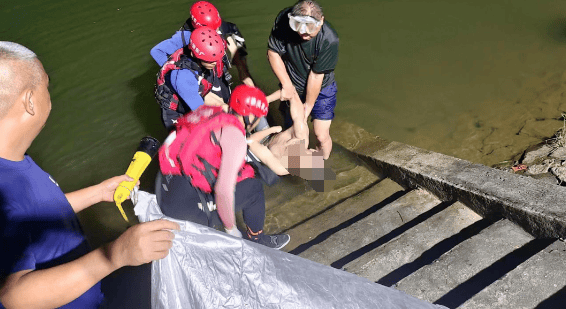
[159,105,255,193]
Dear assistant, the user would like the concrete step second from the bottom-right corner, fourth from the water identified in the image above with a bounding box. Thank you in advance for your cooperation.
[396,220,533,308]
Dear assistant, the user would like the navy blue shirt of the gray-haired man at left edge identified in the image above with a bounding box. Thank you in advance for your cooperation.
[0,155,103,308]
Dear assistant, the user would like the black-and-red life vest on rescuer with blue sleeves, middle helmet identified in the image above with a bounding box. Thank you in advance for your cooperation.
[155,48,212,114]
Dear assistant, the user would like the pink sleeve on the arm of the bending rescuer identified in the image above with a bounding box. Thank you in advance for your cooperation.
[214,126,247,229]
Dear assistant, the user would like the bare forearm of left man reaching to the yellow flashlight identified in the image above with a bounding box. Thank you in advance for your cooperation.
[65,175,133,213]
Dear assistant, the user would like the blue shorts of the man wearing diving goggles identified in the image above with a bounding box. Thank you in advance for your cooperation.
[280,81,338,128]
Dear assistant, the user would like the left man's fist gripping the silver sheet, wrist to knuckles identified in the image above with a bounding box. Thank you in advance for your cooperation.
[107,220,180,268]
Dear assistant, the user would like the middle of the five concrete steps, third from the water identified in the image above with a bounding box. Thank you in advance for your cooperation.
[346,202,483,285]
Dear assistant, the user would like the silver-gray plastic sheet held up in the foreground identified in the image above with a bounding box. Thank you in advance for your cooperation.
[133,191,445,309]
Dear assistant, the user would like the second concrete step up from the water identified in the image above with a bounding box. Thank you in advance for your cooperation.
[300,188,446,265]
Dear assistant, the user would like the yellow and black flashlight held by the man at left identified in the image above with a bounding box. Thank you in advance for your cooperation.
[114,136,160,222]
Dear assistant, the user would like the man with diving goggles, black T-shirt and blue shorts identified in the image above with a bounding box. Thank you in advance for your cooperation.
[267,0,339,159]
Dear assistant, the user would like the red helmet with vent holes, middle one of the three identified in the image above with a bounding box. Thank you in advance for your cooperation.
[189,27,225,62]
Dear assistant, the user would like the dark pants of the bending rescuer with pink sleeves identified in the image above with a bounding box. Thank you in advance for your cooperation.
[155,175,265,232]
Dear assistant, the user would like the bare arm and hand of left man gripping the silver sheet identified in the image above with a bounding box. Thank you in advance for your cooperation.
[0,220,179,308]
